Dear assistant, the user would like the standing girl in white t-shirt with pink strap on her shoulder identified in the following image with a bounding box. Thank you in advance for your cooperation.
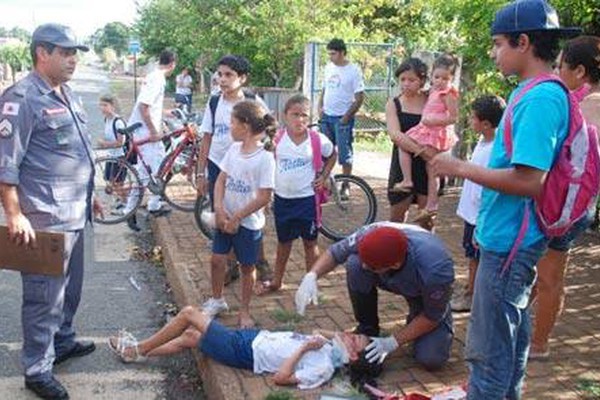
[256,94,336,295]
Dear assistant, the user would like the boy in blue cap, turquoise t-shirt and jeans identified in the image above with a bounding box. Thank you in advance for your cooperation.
[432,0,578,400]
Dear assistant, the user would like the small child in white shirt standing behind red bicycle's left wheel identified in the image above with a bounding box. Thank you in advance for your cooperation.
[98,94,127,209]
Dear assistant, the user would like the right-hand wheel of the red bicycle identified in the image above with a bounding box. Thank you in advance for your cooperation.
[159,145,198,212]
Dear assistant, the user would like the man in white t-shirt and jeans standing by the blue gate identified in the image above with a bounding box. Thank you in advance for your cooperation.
[319,39,365,197]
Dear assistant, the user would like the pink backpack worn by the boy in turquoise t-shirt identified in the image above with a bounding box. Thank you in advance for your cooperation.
[504,75,600,268]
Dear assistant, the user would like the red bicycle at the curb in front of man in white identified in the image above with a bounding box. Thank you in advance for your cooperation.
[94,118,201,224]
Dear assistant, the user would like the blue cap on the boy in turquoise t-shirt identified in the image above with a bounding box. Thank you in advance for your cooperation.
[492,0,581,37]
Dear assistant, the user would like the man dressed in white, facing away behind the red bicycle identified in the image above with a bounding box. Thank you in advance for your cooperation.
[126,50,177,230]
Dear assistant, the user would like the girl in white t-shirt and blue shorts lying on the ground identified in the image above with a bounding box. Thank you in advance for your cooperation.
[108,306,383,389]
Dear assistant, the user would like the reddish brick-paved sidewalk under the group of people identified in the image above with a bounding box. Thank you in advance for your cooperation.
[153,171,600,400]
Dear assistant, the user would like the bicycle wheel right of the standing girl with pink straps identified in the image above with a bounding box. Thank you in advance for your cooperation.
[319,174,377,241]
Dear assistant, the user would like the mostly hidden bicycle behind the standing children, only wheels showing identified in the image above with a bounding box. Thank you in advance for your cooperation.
[194,174,377,242]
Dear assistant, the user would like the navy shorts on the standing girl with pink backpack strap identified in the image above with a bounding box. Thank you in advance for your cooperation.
[273,195,319,243]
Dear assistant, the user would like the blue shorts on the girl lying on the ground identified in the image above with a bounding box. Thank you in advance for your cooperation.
[198,319,260,371]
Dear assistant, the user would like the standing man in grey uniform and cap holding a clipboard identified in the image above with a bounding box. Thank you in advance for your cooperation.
[0,24,100,399]
